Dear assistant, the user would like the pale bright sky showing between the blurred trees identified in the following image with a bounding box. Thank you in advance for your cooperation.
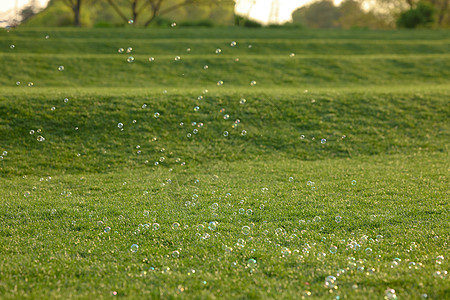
[0,0,342,26]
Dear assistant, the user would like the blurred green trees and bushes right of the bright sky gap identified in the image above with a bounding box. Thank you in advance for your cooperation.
[292,0,450,29]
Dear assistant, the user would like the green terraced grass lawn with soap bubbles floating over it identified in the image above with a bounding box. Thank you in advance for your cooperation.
[0,28,450,299]
